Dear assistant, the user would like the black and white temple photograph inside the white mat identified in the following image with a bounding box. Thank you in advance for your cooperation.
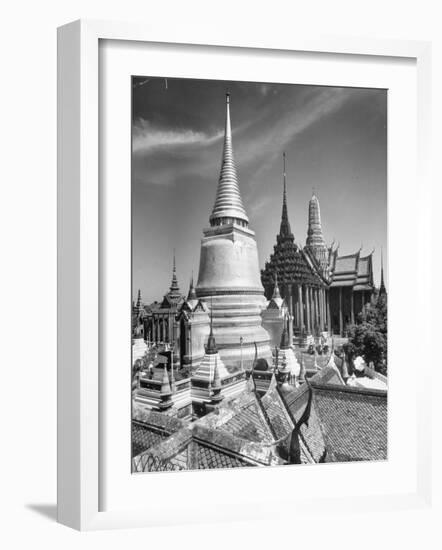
[127,75,388,473]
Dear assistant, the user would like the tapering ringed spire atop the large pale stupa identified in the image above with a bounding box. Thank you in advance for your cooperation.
[210,93,249,226]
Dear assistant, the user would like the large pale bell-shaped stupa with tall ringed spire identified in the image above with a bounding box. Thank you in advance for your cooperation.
[196,94,272,368]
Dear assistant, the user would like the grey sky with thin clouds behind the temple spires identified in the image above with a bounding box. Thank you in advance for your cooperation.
[132,76,388,303]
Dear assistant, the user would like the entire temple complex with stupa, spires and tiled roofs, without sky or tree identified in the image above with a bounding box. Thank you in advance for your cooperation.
[132,90,388,472]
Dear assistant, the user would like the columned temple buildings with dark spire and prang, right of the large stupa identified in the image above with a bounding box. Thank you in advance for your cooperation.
[261,154,374,338]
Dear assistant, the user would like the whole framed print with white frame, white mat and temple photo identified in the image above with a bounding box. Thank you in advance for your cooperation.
[58,22,429,529]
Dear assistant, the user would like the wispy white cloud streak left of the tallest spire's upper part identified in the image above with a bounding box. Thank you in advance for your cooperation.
[132,119,223,153]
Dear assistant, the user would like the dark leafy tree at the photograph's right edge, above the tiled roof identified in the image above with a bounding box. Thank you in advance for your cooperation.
[344,295,388,374]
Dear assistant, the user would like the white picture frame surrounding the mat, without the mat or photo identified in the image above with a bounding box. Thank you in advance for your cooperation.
[58,21,431,530]
